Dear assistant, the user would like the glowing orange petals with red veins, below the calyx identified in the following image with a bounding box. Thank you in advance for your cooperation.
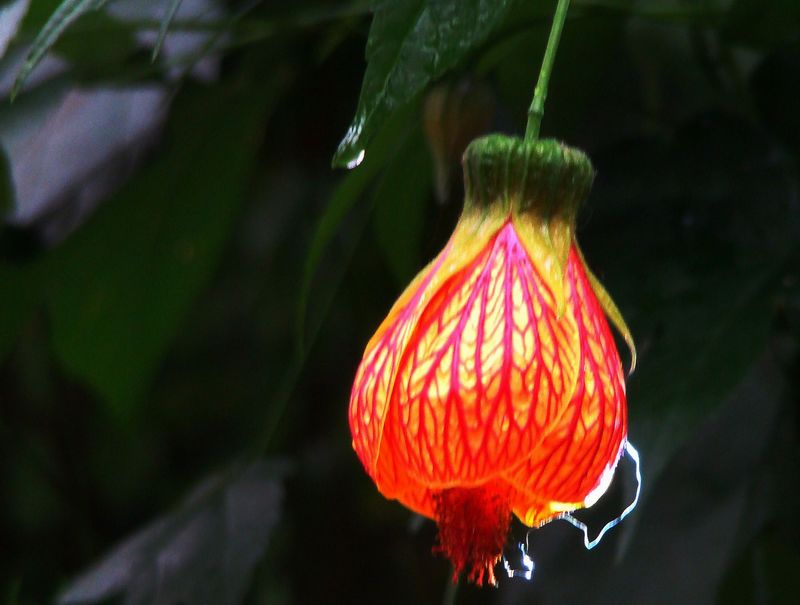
[350,218,627,580]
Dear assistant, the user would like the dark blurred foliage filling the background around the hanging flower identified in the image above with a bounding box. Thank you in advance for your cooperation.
[0,0,800,605]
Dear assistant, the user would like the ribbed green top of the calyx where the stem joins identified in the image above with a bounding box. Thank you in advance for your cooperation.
[462,134,594,221]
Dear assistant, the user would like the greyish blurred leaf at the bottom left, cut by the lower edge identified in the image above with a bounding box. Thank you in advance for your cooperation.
[57,462,285,605]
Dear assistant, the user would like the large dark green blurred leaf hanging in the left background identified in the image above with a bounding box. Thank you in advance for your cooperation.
[47,75,277,413]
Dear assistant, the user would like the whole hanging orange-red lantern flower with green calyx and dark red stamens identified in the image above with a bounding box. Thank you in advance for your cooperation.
[349,135,633,584]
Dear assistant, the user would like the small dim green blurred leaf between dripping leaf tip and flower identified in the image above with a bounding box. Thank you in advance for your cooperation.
[374,122,433,287]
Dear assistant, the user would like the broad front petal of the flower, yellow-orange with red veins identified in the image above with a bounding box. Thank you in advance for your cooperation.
[380,220,578,489]
